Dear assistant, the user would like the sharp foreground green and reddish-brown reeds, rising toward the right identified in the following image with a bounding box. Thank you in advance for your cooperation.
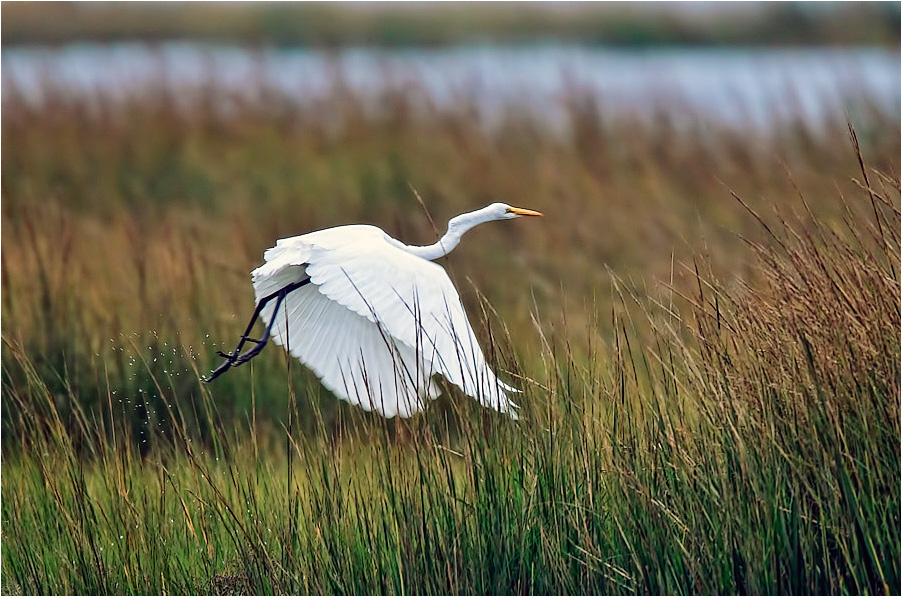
[4,161,900,593]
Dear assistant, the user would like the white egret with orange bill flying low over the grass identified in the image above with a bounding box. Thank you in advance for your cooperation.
[205,203,542,419]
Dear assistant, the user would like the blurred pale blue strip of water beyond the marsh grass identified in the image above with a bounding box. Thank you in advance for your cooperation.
[2,43,900,128]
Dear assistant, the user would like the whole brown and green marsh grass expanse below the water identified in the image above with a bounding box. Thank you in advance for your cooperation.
[2,78,901,594]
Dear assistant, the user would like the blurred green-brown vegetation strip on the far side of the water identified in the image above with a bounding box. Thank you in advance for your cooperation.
[0,2,900,47]
